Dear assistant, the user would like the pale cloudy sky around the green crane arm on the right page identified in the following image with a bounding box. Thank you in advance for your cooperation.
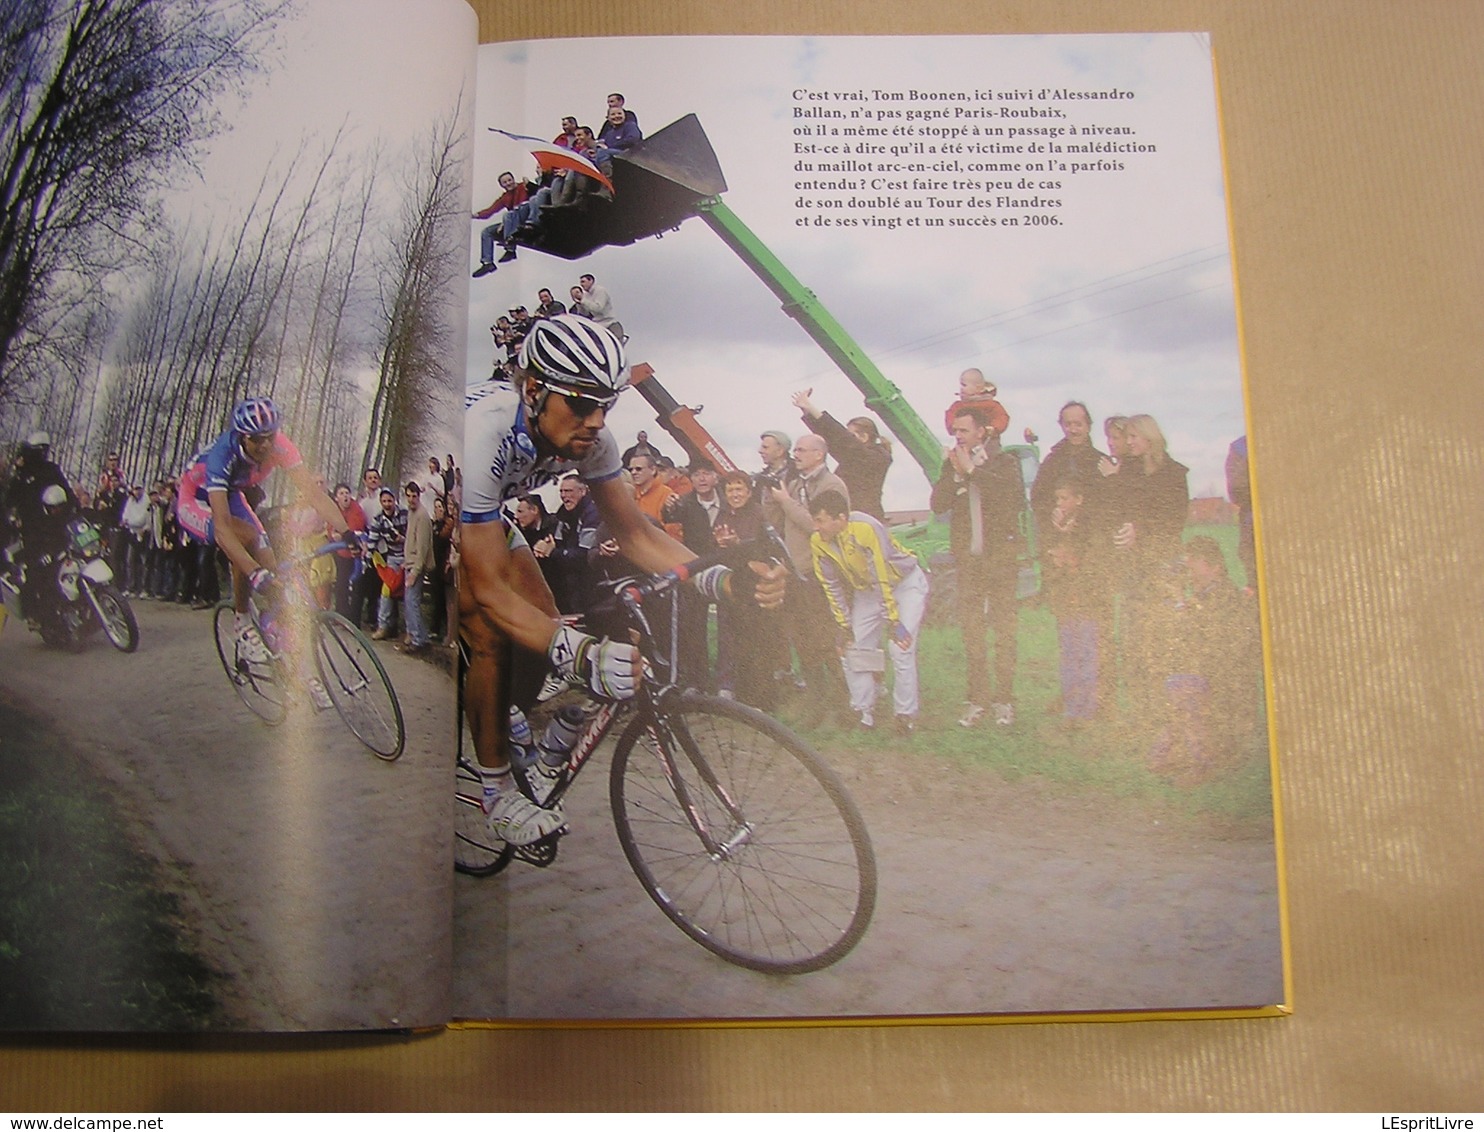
[469,34,1245,507]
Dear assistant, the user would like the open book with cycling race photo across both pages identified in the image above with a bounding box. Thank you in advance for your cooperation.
[0,0,1288,1031]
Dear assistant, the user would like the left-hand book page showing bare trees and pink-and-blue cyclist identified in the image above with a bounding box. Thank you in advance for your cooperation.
[0,0,475,1031]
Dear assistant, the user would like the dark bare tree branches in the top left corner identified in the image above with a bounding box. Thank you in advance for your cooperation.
[0,0,283,402]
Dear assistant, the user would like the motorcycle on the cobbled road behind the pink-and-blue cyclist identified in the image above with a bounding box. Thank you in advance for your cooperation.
[0,518,139,653]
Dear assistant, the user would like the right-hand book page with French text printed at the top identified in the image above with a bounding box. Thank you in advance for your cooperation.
[454,34,1285,1021]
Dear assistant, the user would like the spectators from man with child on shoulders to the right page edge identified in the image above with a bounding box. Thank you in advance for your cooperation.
[973,385,1261,783]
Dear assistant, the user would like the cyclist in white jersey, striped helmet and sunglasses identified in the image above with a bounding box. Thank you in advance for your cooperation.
[459,315,787,846]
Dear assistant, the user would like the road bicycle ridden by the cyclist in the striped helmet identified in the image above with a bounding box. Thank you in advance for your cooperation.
[454,574,876,973]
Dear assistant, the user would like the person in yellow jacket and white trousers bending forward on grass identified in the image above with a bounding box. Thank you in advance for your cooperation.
[809,491,928,734]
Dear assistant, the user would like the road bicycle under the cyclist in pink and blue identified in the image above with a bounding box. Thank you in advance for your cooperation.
[215,542,407,763]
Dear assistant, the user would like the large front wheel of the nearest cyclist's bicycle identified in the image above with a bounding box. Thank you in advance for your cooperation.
[608,693,876,975]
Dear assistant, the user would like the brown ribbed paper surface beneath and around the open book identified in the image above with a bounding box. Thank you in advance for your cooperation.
[0,0,1484,1113]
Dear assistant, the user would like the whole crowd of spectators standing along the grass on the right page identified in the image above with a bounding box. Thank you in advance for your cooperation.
[489,369,1260,780]
